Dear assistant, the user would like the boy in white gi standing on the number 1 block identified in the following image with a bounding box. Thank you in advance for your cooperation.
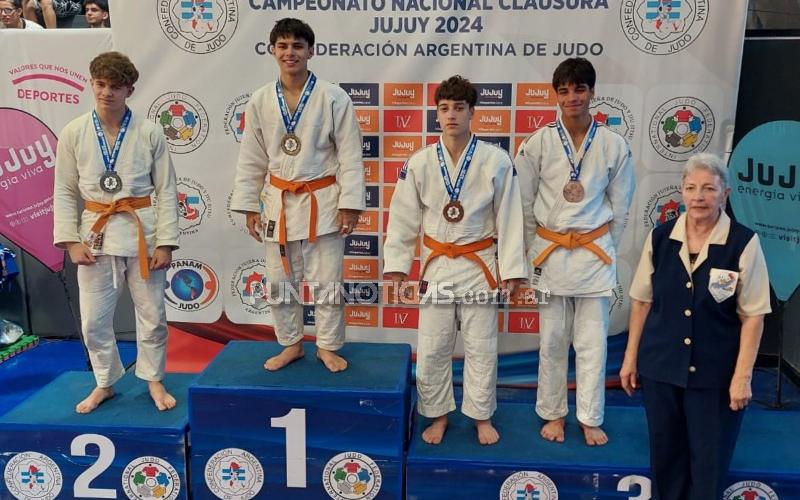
[231,18,365,372]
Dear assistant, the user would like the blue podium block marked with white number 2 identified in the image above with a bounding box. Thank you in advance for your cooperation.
[0,372,194,500]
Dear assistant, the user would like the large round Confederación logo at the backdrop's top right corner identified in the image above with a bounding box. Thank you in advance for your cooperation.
[619,0,710,55]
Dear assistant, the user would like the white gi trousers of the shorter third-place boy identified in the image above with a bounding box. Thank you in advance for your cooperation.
[417,304,497,420]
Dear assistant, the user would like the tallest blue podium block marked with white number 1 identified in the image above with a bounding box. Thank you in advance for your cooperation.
[189,342,411,500]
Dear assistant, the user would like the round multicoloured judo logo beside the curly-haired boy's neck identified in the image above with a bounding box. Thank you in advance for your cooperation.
[147,92,209,154]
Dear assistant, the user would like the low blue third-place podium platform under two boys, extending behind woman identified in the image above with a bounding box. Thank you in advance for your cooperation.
[406,403,800,500]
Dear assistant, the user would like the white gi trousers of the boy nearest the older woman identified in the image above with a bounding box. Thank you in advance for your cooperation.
[536,295,609,427]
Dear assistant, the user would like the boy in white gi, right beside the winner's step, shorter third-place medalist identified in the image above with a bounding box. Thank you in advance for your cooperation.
[383,76,527,444]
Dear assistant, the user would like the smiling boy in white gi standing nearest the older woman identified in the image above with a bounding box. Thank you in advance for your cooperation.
[514,58,634,445]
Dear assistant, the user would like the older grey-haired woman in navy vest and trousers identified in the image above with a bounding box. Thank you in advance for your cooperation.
[620,154,771,500]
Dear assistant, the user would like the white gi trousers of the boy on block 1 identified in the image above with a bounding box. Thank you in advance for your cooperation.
[265,233,345,351]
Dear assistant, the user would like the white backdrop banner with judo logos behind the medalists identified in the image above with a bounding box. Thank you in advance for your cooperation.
[112,0,747,353]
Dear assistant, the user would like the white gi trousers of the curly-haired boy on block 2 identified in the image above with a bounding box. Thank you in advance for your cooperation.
[78,255,167,388]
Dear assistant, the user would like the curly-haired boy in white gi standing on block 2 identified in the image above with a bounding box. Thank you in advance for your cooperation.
[53,52,179,413]
